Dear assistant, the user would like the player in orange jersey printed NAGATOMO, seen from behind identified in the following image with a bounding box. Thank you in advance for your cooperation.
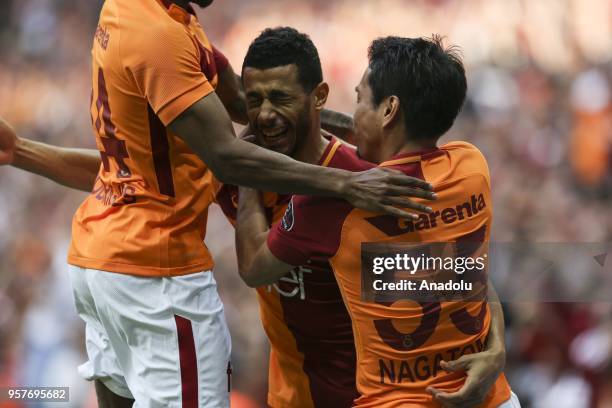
[236,37,518,407]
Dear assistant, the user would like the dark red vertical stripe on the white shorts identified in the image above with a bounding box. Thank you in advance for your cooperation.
[174,315,198,408]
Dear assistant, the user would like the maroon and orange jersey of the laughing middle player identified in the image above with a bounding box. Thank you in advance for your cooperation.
[216,138,373,408]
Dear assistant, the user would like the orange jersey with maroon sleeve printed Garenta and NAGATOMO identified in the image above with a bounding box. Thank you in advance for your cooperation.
[268,142,510,408]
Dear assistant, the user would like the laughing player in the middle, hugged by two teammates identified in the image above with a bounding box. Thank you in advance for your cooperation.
[0,28,503,407]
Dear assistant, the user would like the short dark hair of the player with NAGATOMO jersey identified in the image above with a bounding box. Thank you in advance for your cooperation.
[368,35,467,138]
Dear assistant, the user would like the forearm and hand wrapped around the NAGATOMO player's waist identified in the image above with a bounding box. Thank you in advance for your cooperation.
[428,282,506,408]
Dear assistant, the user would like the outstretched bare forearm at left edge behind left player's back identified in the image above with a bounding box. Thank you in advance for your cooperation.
[0,118,100,191]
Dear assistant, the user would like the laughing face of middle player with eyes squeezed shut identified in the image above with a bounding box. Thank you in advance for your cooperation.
[242,64,311,155]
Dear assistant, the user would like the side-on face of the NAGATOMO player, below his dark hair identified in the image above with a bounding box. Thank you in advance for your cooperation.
[353,69,382,163]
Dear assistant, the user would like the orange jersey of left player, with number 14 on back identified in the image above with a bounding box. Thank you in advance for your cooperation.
[68,0,227,277]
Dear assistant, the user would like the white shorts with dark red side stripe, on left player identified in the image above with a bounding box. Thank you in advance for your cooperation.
[70,265,231,408]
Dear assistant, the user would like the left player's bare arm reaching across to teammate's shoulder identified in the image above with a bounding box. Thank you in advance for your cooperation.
[169,92,434,218]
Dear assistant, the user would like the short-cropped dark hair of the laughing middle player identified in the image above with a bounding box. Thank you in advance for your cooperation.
[242,27,323,92]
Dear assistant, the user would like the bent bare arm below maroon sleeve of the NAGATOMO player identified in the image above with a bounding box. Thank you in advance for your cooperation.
[236,187,293,288]
